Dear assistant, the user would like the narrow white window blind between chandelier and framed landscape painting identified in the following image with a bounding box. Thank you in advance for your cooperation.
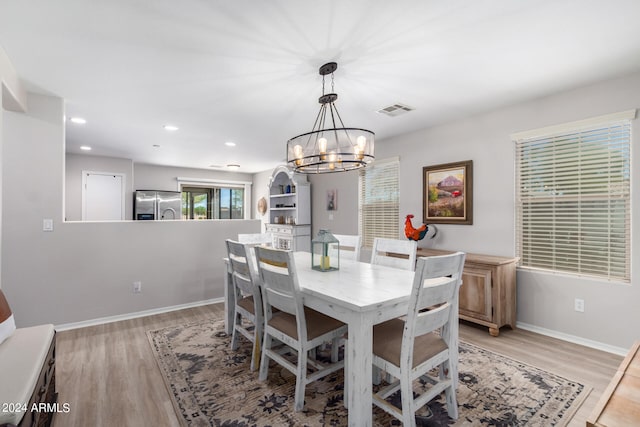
[358,157,400,248]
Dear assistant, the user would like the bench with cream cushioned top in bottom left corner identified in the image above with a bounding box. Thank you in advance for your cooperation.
[0,291,57,427]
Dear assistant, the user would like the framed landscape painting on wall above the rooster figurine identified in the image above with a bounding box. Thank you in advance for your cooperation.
[422,160,473,225]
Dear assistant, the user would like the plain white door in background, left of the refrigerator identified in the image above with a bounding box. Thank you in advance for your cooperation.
[82,171,125,221]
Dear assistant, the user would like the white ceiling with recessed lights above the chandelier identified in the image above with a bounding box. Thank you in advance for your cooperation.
[0,0,640,172]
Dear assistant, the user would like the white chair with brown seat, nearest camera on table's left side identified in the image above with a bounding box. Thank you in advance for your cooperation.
[255,246,347,411]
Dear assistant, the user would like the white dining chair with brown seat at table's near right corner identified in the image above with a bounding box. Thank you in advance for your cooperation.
[372,252,466,426]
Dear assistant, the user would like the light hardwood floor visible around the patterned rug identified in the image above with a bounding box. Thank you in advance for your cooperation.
[53,304,622,427]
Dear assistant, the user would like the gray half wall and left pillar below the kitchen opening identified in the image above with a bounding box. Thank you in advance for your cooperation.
[2,95,260,327]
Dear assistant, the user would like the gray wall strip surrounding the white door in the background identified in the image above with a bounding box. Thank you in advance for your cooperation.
[64,153,133,221]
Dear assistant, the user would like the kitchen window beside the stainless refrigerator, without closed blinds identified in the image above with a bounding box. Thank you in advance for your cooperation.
[182,187,244,219]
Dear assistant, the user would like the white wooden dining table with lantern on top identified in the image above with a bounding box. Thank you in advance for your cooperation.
[225,252,424,427]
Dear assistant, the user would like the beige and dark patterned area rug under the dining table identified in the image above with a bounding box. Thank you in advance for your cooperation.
[147,319,590,427]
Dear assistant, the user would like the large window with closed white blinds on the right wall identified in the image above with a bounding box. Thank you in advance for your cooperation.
[512,110,635,282]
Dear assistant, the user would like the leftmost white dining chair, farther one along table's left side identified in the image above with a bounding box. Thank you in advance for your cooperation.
[226,239,264,371]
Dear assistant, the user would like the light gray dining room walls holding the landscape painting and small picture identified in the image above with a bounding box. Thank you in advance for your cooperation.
[311,73,640,350]
